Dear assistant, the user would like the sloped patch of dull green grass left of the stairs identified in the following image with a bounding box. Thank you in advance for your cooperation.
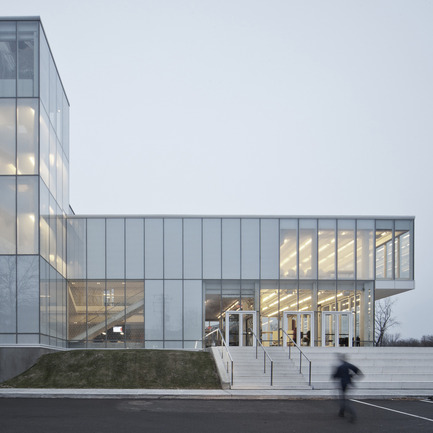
[1,349,221,389]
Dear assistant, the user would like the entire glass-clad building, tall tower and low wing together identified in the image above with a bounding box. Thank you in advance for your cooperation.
[0,18,414,348]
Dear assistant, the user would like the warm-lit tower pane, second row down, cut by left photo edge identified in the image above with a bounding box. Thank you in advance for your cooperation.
[0,98,16,174]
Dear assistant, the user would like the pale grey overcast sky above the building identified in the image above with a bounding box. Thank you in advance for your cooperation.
[1,0,433,338]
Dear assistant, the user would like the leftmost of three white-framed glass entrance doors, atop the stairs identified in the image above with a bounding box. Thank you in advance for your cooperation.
[224,311,257,347]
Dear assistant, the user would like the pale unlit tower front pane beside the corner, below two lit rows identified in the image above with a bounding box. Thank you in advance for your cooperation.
[17,256,39,333]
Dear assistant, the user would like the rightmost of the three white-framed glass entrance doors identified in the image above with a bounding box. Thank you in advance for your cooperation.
[322,311,353,347]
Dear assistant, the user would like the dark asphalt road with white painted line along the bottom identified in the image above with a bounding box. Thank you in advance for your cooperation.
[0,398,433,433]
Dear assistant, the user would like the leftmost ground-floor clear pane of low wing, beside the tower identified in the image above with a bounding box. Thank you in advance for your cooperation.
[68,281,86,341]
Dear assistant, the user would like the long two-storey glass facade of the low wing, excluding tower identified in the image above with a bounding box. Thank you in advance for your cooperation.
[67,216,413,348]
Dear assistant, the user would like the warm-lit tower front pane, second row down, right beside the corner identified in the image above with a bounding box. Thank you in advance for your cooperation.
[17,99,39,174]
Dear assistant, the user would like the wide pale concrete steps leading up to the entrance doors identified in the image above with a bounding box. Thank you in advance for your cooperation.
[212,347,433,392]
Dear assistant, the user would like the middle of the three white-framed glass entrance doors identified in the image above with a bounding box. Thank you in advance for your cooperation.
[283,311,314,346]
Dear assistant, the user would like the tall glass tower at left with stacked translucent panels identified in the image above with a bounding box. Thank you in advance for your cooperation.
[0,18,69,346]
